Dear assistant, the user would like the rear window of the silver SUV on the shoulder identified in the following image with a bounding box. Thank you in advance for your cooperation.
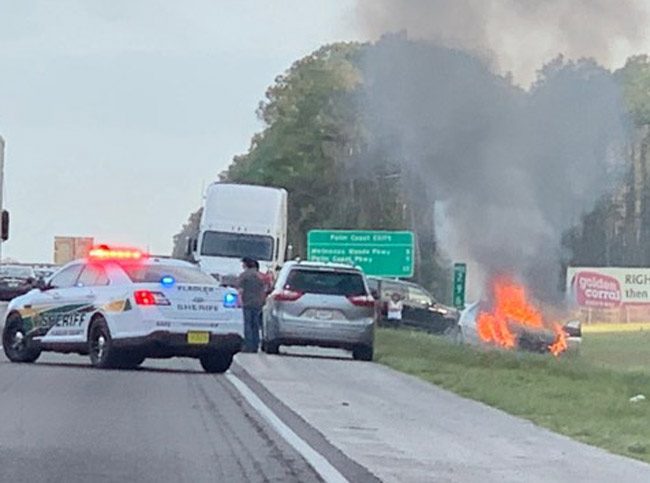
[285,269,367,297]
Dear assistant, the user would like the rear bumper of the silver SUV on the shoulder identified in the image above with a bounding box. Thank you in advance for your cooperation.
[269,318,375,349]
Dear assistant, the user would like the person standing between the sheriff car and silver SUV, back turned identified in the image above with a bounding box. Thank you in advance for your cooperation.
[237,257,266,352]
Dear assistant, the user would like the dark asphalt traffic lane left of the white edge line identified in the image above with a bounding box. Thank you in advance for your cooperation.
[0,355,319,482]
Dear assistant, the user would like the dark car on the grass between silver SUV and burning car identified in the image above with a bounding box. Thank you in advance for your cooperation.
[368,277,459,334]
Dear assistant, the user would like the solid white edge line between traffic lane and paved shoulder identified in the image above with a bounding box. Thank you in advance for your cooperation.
[226,374,349,483]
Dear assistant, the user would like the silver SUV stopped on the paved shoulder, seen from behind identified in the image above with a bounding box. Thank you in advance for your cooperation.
[262,261,376,361]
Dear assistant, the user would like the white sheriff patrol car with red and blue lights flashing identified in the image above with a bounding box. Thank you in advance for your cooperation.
[2,246,243,372]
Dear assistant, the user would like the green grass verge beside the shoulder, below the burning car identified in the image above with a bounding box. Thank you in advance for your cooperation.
[375,329,650,462]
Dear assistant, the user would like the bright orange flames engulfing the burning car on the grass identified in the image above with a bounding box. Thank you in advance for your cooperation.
[477,278,567,356]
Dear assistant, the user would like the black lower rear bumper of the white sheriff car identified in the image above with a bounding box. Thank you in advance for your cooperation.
[113,330,243,358]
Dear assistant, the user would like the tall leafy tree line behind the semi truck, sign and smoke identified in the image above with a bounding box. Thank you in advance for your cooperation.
[173,38,650,300]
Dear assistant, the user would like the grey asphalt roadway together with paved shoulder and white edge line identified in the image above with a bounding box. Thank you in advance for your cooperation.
[0,306,650,483]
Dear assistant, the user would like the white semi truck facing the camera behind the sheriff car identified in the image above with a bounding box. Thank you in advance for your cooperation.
[188,182,288,285]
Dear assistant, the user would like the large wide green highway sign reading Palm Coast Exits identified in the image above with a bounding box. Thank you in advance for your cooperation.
[307,230,414,278]
